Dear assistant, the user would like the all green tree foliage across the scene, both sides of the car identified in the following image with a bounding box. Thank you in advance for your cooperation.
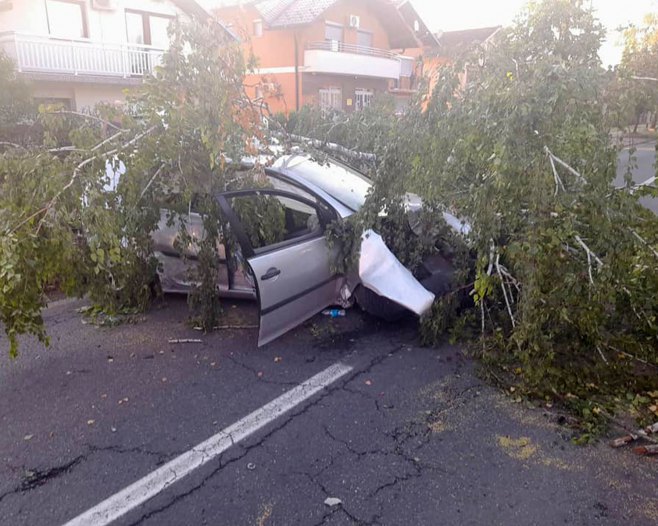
[0,0,658,440]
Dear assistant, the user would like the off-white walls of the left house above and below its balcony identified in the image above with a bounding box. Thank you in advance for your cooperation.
[0,0,181,109]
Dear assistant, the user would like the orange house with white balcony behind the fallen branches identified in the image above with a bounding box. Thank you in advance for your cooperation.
[213,0,436,113]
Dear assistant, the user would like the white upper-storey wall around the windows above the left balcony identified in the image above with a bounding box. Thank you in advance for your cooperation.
[0,0,178,42]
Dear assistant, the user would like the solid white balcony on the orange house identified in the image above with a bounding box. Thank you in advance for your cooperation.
[304,40,401,80]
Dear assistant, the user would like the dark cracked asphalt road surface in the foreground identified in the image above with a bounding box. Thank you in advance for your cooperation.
[0,297,658,526]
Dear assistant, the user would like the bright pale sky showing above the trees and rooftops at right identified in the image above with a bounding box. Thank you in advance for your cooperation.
[411,0,658,66]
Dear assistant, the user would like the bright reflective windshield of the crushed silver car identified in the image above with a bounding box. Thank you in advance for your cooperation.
[288,157,372,212]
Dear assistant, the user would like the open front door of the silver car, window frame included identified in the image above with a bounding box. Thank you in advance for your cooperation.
[218,189,343,346]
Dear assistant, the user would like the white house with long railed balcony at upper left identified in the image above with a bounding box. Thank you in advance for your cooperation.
[0,0,220,110]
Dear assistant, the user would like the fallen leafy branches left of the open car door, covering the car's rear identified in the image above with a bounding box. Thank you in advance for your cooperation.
[0,22,259,355]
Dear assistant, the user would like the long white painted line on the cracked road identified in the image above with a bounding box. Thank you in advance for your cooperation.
[64,363,353,526]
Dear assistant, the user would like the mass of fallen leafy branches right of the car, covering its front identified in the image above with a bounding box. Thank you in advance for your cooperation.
[293,0,658,438]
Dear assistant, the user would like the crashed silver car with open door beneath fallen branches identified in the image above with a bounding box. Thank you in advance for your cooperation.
[153,155,451,345]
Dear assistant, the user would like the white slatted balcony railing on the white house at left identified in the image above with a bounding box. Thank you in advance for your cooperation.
[0,33,164,78]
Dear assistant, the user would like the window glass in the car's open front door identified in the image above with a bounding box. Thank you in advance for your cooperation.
[229,194,322,250]
